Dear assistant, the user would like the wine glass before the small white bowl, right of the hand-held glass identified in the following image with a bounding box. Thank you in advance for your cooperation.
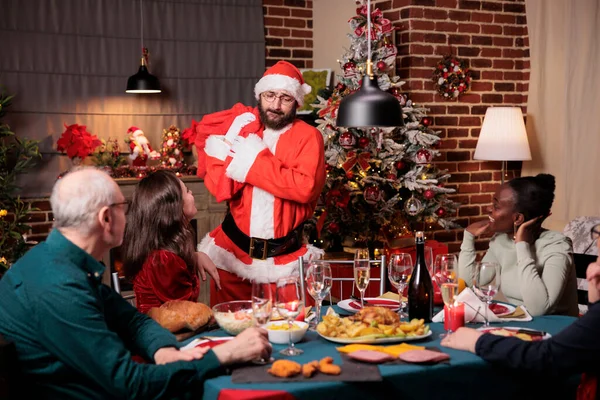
[276,277,304,356]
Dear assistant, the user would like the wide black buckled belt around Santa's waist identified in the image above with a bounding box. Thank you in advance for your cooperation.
[221,213,304,260]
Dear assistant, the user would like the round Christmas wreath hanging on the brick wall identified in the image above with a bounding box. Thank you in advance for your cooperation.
[432,55,472,99]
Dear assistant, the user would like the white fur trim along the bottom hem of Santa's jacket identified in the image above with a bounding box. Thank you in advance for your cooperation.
[198,235,323,282]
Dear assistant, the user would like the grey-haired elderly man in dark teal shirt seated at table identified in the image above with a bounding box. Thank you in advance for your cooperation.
[0,169,271,399]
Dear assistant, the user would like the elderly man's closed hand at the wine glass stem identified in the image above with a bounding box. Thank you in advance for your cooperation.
[213,328,273,365]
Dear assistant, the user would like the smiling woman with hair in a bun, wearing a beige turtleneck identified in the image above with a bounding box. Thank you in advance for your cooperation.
[458,174,578,316]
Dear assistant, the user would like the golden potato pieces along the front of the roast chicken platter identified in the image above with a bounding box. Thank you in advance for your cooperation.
[317,315,429,338]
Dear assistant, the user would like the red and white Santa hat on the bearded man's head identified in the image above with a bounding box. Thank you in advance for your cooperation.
[254,61,312,107]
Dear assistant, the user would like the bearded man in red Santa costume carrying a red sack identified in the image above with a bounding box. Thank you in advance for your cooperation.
[195,61,326,304]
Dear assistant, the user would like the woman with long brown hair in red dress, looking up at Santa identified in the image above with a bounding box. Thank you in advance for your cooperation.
[123,170,200,313]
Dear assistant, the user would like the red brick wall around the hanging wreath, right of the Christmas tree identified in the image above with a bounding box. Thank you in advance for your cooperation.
[373,0,529,252]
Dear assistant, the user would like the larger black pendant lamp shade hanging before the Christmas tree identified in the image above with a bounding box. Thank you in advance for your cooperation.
[336,75,404,128]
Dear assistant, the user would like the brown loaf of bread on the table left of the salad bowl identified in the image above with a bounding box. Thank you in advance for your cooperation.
[148,300,212,333]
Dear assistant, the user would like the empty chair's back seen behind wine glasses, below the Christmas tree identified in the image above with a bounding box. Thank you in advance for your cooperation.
[298,255,387,304]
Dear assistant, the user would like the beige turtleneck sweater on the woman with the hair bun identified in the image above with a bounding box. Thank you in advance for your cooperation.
[458,230,578,316]
